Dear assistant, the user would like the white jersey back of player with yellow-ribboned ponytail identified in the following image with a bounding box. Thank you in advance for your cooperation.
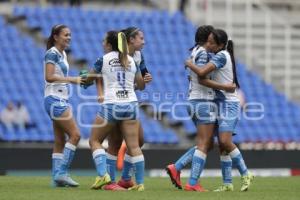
[94,51,139,104]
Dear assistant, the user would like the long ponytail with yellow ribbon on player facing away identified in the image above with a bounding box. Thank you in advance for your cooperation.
[118,32,129,68]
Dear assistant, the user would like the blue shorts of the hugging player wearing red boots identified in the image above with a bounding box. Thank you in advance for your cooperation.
[187,99,217,126]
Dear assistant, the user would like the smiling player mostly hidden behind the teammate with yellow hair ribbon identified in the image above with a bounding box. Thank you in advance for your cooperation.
[97,27,152,190]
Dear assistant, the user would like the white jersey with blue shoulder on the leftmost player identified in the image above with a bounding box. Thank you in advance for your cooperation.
[44,47,69,99]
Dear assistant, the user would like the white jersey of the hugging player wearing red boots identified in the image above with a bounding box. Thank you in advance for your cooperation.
[189,46,215,100]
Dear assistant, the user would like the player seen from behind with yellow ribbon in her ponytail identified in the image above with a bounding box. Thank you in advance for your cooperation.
[87,31,145,191]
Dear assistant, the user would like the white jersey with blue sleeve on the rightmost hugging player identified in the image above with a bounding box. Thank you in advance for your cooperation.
[209,50,239,101]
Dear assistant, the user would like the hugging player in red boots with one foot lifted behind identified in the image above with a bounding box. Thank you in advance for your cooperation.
[166,26,235,192]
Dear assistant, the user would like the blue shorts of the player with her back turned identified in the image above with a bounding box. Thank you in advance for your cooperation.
[98,102,139,123]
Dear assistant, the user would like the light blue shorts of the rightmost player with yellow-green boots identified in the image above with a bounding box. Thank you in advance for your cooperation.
[217,101,240,133]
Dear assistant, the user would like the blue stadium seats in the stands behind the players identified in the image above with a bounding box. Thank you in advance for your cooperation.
[0,6,300,144]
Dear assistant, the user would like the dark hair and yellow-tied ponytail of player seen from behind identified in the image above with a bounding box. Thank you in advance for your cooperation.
[106,31,129,68]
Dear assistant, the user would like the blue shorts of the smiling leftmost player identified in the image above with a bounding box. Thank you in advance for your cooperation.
[44,96,70,119]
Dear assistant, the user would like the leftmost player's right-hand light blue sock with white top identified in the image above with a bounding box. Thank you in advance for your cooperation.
[59,142,76,174]
